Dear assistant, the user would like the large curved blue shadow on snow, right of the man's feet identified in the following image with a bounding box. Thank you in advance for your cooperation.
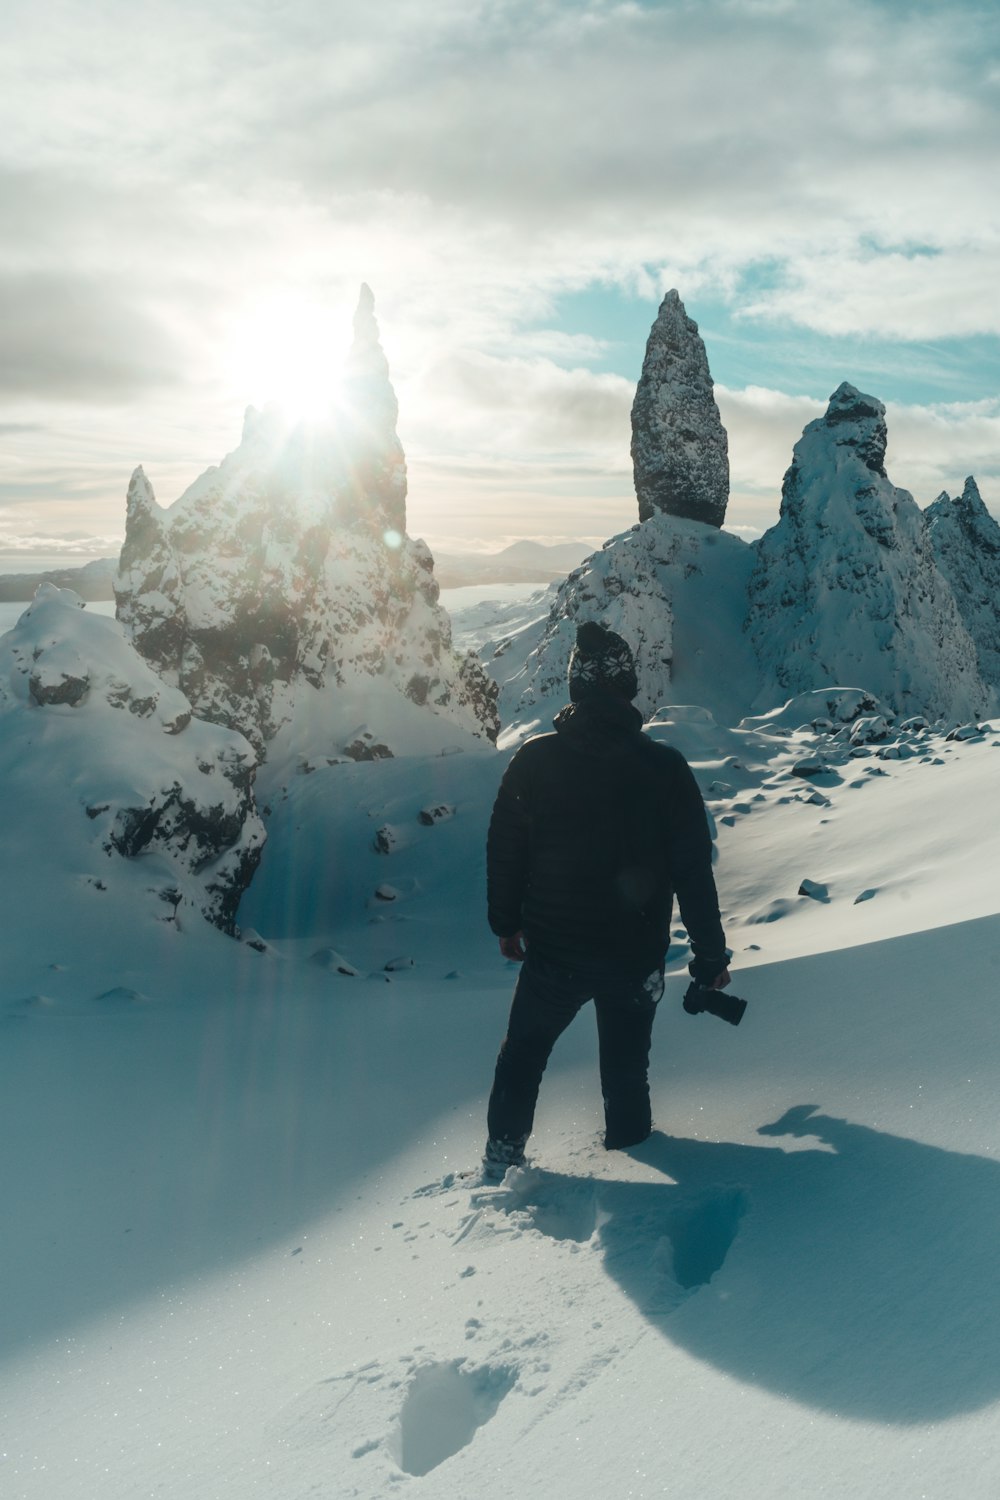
[515,1106,1000,1424]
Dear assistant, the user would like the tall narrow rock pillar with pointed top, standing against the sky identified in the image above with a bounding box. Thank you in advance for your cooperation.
[631,291,729,527]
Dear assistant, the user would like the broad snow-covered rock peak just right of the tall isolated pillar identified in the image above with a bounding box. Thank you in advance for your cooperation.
[747,384,990,719]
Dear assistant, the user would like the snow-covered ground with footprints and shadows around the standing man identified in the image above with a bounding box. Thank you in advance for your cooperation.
[0,615,1000,1500]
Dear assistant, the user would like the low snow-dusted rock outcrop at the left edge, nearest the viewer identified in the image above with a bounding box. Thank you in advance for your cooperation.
[0,584,265,933]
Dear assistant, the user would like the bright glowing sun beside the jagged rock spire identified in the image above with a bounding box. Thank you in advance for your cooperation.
[226,291,351,422]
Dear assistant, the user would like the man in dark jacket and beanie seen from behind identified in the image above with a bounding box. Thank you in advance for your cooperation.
[483,621,729,1176]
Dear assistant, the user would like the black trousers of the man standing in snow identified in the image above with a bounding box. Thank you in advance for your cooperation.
[487,954,663,1149]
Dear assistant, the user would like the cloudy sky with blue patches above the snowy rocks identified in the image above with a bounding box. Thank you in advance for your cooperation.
[0,0,1000,570]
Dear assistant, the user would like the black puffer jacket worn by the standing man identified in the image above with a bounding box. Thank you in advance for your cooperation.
[487,693,726,975]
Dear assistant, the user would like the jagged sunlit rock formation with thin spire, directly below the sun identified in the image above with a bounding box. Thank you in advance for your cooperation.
[115,287,498,758]
